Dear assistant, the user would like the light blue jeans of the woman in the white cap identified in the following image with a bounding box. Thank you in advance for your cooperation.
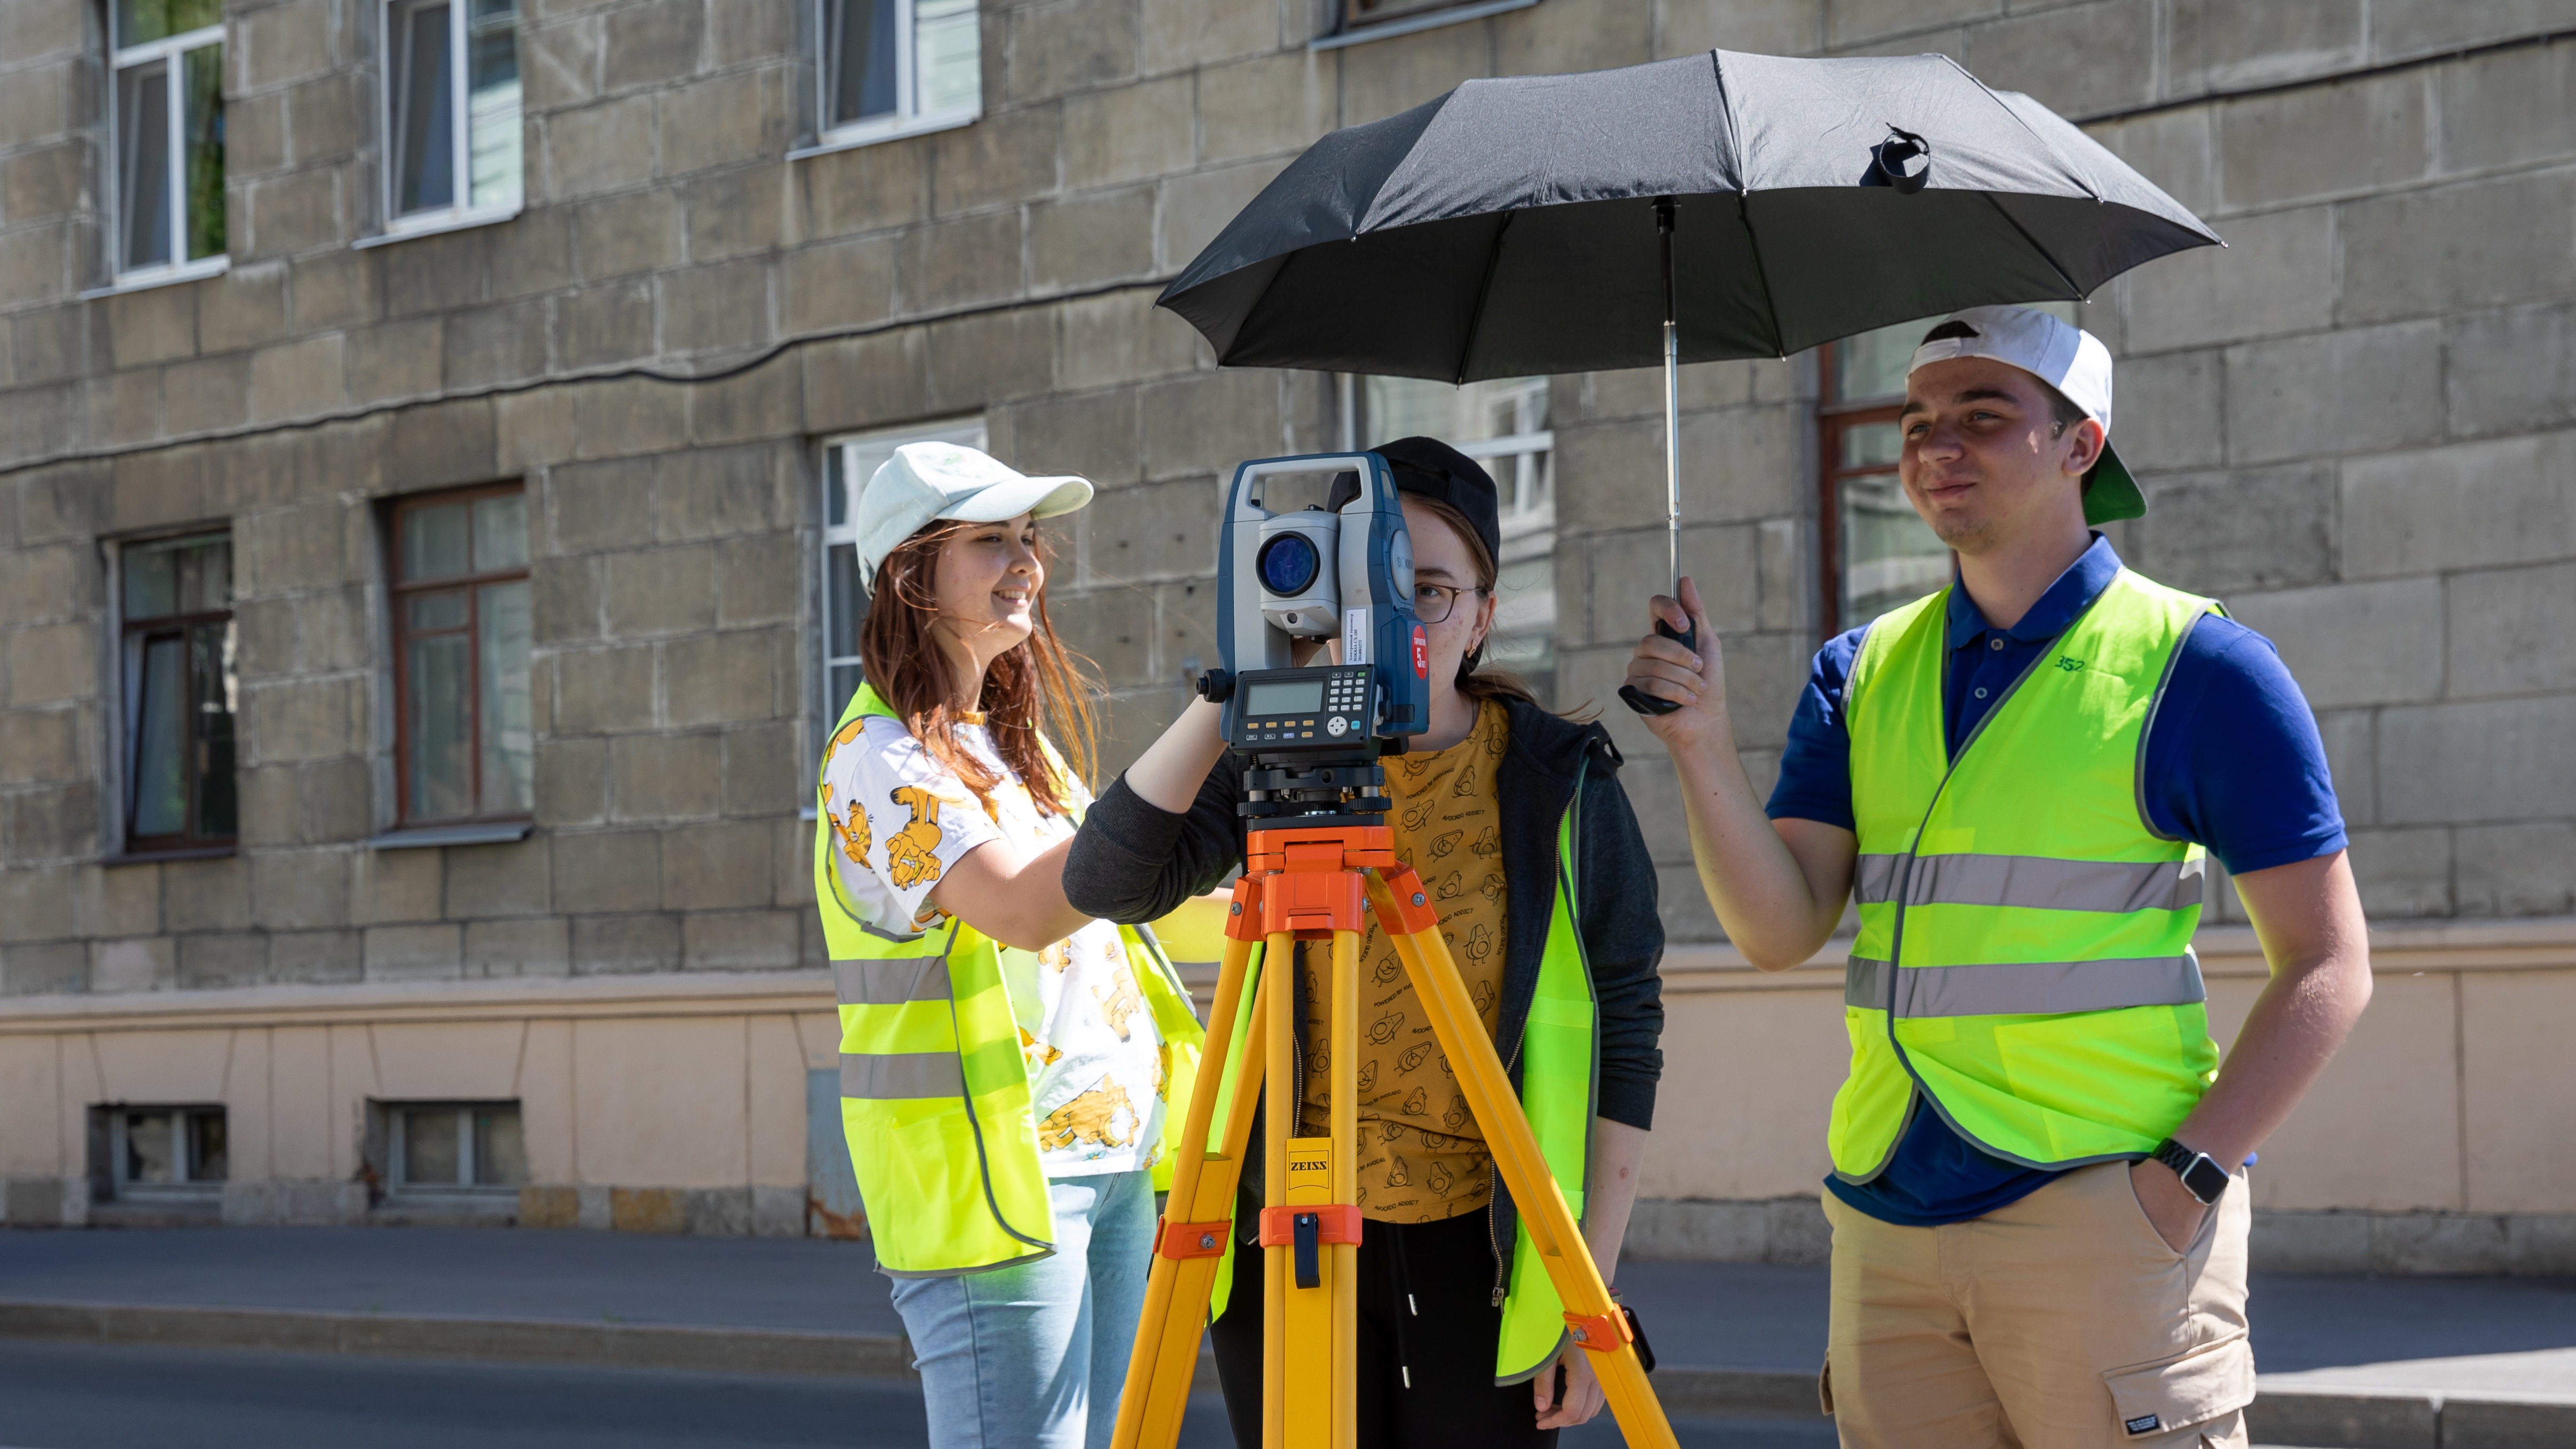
[894,1171,1154,1449]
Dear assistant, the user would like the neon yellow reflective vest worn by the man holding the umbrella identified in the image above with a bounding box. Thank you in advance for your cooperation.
[1829,569,2218,1181]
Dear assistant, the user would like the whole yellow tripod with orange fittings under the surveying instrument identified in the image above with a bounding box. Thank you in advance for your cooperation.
[1113,824,1674,1449]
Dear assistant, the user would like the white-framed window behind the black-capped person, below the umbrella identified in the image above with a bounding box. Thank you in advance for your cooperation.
[1355,378,1556,700]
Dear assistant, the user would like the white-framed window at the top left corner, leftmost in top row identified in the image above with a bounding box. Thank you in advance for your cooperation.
[108,0,226,283]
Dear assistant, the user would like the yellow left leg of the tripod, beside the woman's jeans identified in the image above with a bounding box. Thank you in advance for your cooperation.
[1110,939,1270,1449]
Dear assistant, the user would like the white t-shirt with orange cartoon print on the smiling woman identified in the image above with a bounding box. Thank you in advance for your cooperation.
[822,716,1172,1176]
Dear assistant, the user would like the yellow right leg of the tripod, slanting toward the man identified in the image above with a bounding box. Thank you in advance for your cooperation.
[1371,870,1677,1449]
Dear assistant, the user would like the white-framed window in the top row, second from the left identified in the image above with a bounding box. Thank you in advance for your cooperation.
[384,0,526,232]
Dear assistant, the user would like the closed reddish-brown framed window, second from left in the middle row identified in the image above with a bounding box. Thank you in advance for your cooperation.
[389,484,536,826]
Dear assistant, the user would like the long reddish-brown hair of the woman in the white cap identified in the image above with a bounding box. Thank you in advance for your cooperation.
[858,522,1100,816]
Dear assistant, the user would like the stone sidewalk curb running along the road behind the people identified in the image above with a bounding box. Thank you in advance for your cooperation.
[0,1302,2576,1449]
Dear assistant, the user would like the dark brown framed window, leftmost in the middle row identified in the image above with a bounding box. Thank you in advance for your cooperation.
[119,532,240,855]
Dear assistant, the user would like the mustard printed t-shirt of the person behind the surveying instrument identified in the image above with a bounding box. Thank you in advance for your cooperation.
[1298,700,1509,1223]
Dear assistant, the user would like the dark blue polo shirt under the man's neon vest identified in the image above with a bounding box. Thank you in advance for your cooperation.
[1769,532,2344,1228]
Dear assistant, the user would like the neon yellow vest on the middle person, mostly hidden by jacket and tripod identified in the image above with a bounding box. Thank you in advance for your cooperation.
[1200,764,1600,1385]
